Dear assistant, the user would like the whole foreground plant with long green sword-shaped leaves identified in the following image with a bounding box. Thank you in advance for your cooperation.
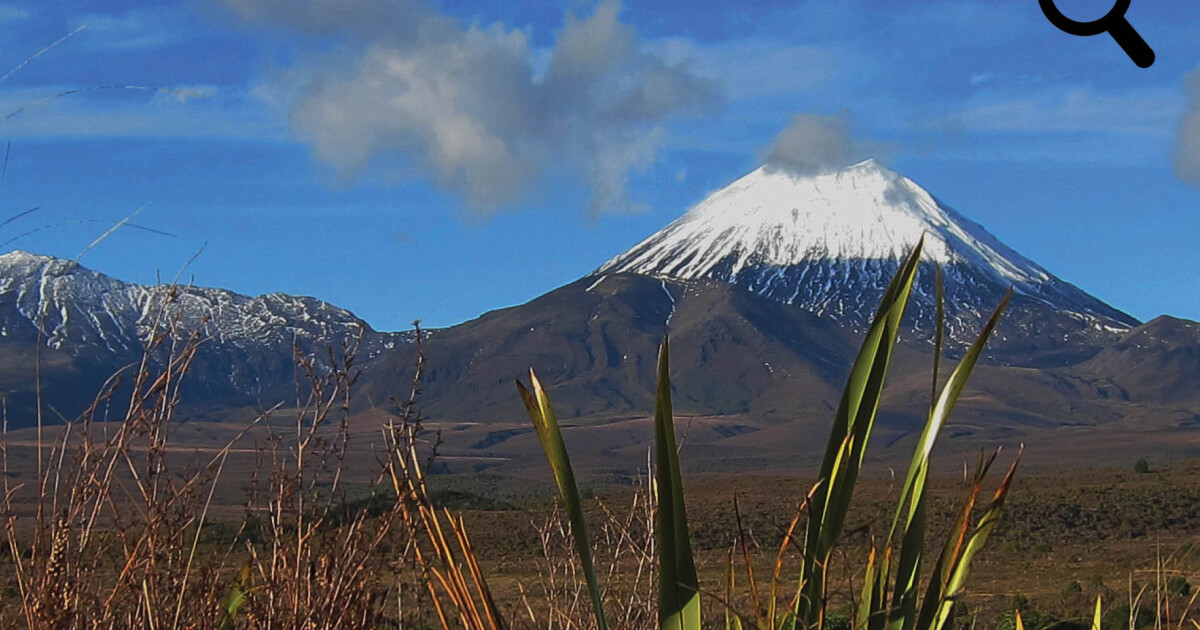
[517,237,1016,630]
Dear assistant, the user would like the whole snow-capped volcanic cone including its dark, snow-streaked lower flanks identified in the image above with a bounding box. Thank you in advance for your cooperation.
[595,160,1138,352]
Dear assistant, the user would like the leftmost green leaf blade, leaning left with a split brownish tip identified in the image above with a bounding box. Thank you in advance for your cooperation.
[517,370,608,630]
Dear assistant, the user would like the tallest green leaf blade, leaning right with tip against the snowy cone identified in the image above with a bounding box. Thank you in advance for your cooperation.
[794,238,924,628]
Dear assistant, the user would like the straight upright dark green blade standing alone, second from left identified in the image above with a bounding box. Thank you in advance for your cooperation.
[654,340,700,630]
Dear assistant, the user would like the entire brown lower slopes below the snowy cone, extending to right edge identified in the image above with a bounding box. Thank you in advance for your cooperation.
[364,274,1200,474]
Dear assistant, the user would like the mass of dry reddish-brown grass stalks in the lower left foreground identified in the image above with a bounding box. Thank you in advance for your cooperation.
[0,274,508,630]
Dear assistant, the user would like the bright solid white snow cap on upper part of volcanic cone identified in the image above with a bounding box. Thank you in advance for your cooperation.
[598,160,1050,283]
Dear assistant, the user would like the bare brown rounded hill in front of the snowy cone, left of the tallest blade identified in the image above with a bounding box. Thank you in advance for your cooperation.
[364,274,854,421]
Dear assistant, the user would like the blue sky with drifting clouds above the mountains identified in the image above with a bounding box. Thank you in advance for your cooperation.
[0,0,1200,330]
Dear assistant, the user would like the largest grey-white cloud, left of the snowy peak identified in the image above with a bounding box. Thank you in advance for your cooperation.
[224,0,718,214]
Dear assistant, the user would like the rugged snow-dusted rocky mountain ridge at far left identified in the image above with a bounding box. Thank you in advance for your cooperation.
[0,251,408,426]
